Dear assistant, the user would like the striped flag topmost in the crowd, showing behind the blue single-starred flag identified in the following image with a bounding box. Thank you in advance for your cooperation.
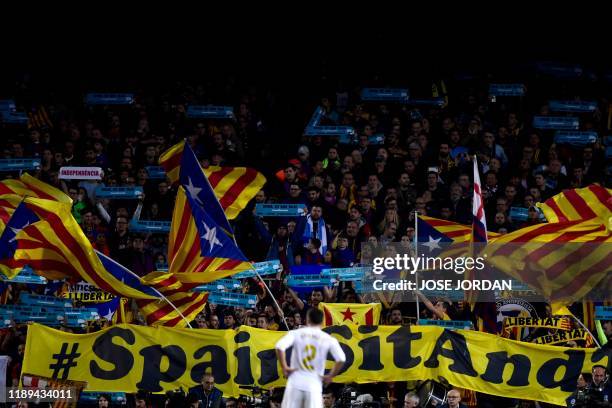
[159,141,266,220]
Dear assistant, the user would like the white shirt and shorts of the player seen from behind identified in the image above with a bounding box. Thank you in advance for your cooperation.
[276,327,346,408]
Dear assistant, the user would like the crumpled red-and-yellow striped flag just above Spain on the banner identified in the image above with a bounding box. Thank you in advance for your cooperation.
[136,272,208,327]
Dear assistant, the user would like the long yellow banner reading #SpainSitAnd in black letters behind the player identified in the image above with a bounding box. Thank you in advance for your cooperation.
[23,324,608,405]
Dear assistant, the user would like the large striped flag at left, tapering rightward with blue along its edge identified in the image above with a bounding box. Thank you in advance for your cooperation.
[0,197,157,299]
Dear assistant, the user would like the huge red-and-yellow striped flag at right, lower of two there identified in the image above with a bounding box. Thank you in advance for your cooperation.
[484,219,612,304]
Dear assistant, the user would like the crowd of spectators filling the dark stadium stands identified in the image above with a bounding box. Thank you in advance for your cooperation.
[0,65,610,408]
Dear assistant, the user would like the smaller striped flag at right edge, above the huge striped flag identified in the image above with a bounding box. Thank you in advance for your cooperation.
[536,184,612,223]
